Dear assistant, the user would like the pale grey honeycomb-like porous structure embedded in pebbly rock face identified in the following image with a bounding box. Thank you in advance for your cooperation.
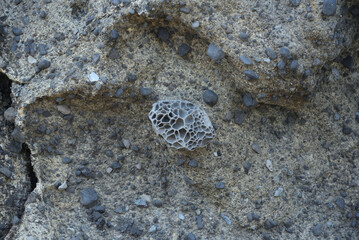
[148,100,215,150]
